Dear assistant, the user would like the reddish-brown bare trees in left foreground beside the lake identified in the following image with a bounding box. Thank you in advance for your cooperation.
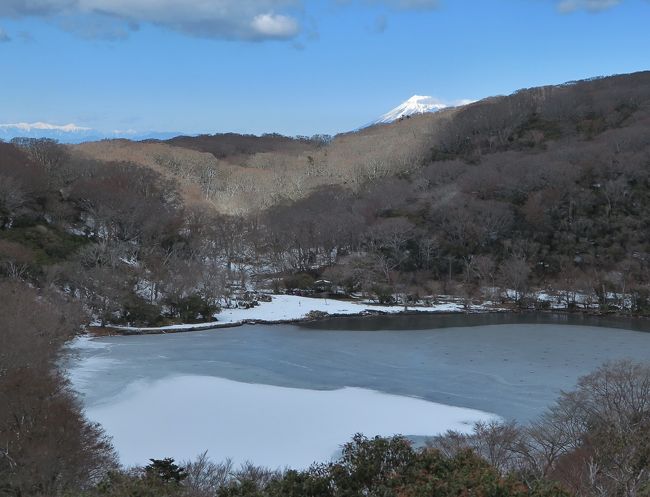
[0,281,118,497]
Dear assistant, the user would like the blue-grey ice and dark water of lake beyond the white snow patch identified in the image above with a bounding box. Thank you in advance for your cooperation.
[68,314,650,421]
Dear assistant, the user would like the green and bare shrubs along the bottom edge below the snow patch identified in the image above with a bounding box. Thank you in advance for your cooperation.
[82,435,570,497]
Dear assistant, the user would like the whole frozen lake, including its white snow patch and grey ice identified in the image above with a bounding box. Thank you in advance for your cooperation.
[64,315,650,467]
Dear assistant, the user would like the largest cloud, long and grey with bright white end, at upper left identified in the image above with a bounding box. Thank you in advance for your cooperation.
[0,0,302,40]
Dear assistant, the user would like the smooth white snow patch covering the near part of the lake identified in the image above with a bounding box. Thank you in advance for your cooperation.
[86,376,495,469]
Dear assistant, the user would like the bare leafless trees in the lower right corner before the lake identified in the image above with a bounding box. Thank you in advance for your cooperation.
[428,361,650,497]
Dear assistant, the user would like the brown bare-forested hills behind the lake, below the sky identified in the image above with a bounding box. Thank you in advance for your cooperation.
[0,73,650,325]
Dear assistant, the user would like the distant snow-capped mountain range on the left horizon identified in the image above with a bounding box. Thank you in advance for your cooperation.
[0,122,182,144]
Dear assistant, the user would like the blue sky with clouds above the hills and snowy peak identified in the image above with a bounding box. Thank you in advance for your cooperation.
[0,0,650,135]
